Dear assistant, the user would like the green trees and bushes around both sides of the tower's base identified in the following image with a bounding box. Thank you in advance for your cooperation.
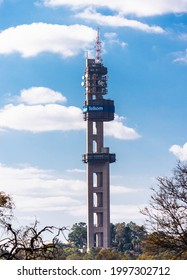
[68,222,147,259]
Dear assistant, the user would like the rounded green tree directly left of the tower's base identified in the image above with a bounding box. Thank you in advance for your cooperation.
[68,222,87,249]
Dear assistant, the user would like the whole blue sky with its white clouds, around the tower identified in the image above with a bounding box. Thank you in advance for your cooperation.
[0,0,187,235]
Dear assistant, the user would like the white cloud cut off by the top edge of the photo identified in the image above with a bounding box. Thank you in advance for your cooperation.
[43,0,187,17]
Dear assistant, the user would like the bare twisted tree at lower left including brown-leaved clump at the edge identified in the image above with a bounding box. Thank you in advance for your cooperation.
[0,192,66,260]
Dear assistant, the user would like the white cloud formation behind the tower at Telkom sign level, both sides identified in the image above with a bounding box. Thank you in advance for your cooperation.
[0,87,140,140]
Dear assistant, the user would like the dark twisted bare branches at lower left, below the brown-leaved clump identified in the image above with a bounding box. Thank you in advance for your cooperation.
[0,221,68,260]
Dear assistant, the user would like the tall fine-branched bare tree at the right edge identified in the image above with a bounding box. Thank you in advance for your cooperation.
[142,162,187,259]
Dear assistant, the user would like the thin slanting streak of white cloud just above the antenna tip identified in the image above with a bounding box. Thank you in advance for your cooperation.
[76,9,165,33]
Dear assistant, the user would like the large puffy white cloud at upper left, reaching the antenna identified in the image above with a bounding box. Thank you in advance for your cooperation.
[0,23,96,58]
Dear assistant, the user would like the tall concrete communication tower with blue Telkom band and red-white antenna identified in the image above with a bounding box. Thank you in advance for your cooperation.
[82,30,116,250]
